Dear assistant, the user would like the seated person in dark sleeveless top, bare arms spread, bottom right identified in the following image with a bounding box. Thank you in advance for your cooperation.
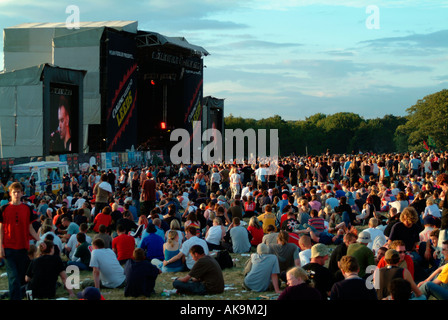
[373,249,422,300]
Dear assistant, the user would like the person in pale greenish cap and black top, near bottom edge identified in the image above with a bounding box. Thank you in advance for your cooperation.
[302,243,334,300]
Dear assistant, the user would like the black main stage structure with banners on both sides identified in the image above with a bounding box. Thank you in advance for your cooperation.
[88,28,211,160]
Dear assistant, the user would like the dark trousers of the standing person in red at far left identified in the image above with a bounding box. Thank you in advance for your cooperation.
[5,248,30,300]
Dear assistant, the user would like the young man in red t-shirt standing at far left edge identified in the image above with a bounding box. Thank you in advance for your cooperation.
[0,182,40,300]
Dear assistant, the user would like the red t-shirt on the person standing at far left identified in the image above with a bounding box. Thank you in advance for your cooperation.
[0,203,36,250]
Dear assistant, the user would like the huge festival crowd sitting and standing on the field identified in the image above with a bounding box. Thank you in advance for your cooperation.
[0,151,448,300]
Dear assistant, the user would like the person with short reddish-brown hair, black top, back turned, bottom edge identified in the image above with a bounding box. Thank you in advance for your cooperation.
[330,256,378,301]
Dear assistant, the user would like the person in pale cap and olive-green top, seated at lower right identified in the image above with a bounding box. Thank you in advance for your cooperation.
[347,231,375,278]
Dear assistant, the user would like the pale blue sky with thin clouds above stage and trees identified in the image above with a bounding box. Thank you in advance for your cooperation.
[0,0,448,120]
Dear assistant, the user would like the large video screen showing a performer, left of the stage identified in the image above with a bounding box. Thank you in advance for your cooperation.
[49,83,79,154]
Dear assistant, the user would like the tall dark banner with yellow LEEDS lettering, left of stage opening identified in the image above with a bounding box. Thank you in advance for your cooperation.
[105,31,137,152]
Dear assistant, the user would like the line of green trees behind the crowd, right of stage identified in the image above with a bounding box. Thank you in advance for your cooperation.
[224,90,448,156]
